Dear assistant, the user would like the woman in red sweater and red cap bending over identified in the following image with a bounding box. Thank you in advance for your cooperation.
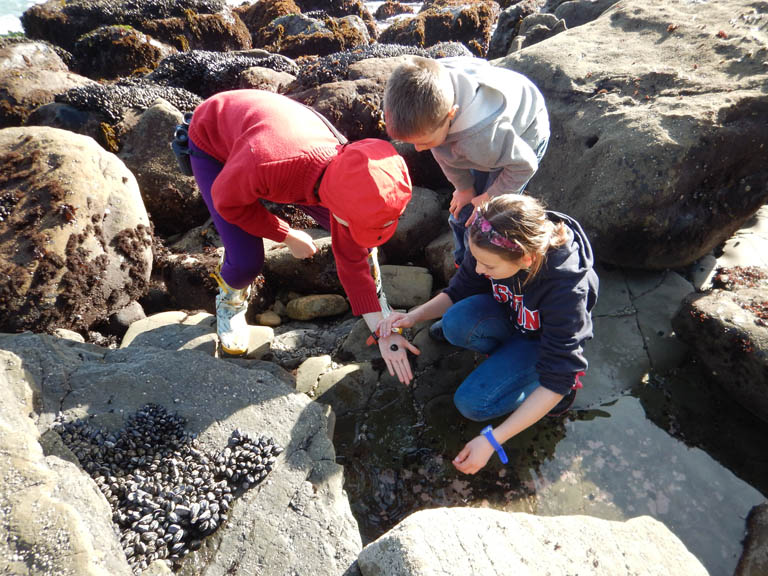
[189,90,418,382]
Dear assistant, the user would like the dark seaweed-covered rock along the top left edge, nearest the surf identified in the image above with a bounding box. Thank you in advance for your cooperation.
[21,0,233,50]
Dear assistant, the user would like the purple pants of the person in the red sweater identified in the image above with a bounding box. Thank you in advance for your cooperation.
[189,140,331,290]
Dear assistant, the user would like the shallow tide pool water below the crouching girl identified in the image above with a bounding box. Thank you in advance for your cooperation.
[334,362,768,575]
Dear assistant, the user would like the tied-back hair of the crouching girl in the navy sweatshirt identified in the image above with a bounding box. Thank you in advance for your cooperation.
[469,194,568,284]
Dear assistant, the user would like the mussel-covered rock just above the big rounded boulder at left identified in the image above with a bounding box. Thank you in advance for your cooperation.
[56,78,201,126]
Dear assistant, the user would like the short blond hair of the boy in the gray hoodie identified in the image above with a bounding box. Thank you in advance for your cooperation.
[384,56,454,139]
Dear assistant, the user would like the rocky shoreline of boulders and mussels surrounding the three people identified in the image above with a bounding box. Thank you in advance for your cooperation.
[0,0,768,576]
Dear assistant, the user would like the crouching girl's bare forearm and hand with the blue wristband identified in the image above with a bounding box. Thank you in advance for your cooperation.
[453,386,563,474]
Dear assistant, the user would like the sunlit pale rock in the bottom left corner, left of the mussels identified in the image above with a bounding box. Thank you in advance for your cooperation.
[0,338,131,576]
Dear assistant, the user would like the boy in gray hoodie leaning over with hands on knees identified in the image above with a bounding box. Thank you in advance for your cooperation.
[384,56,549,267]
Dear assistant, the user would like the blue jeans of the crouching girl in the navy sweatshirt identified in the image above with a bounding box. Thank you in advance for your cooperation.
[442,294,540,422]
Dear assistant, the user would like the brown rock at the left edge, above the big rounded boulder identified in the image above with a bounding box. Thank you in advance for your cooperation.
[0,39,94,128]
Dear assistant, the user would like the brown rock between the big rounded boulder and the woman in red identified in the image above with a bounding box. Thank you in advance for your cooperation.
[118,100,210,236]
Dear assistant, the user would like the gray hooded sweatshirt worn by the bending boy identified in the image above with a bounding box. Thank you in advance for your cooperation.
[432,57,549,197]
